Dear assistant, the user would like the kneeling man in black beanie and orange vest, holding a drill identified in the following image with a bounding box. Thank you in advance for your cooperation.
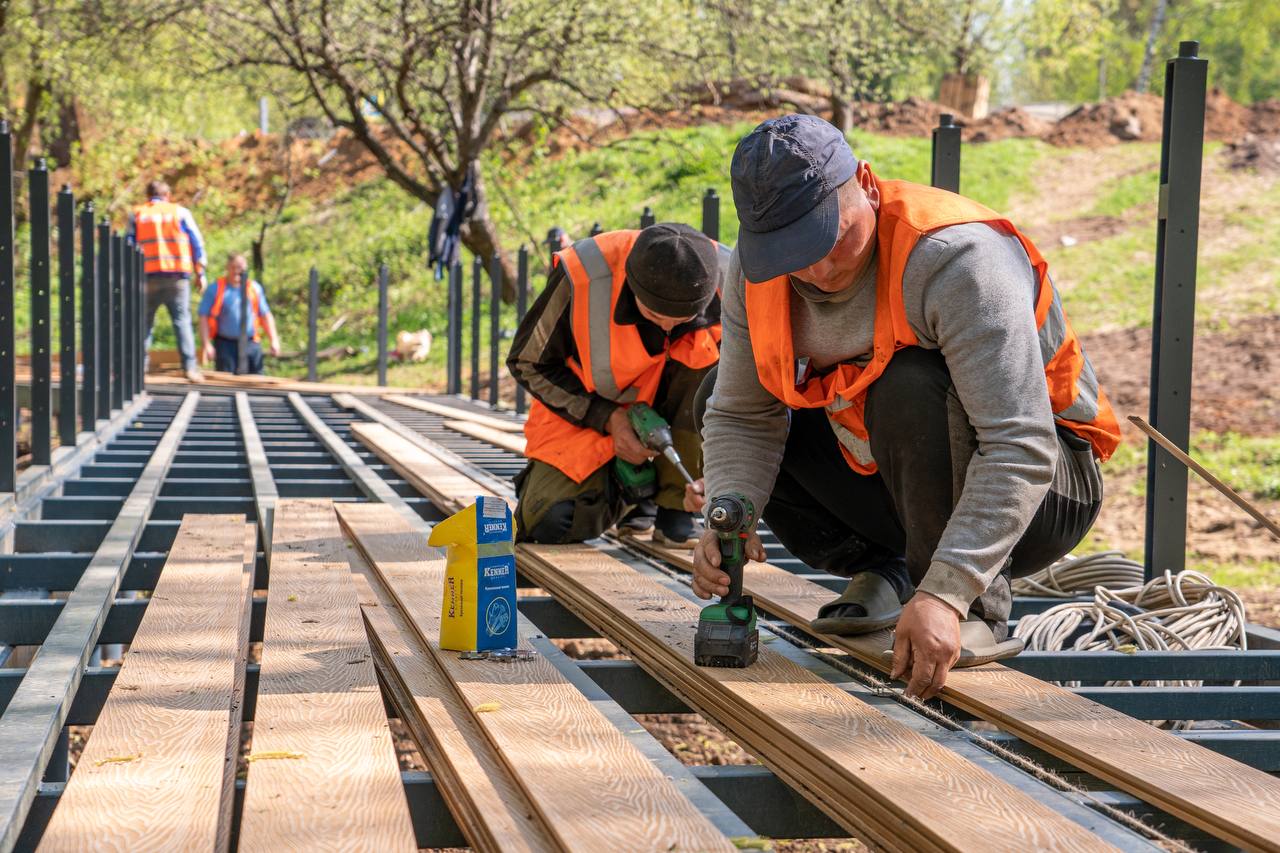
[507,223,728,547]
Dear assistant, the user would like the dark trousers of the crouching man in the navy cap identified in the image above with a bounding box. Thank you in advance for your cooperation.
[700,347,1101,625]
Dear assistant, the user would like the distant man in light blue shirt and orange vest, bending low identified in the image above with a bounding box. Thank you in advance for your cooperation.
[200,255,280,373]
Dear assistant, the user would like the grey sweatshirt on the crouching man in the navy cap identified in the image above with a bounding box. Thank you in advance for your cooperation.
[703,223,1102,613]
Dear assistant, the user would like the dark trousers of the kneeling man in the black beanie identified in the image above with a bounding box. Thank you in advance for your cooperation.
[516,360,710,544]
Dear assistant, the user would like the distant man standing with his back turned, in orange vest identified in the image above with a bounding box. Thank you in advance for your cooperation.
[129,181,205,382]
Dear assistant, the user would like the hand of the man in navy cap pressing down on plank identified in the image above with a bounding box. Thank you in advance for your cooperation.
[891,592,960,699]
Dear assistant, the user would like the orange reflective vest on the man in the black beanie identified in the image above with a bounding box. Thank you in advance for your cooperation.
[525,231,730,483]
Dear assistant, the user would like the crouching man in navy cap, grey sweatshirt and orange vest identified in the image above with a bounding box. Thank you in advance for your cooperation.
[689,115,1120,698]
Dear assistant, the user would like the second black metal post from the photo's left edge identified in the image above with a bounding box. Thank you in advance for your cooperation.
[27,158,54,465]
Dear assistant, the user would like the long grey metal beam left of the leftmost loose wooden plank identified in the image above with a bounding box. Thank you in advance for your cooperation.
[0,393,200,853]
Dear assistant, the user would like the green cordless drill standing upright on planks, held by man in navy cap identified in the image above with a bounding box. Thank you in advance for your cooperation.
[694,494,760,667]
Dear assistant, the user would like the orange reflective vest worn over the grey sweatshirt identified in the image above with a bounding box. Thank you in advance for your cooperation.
[746,171,1120,474]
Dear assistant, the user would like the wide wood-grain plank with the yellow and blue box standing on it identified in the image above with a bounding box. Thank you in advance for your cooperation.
[339,505,733,852]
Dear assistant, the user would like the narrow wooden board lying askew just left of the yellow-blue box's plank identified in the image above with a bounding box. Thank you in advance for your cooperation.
[351,555,558,853]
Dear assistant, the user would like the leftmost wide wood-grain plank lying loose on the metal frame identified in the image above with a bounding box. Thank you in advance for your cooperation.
[40,515,253,852]
